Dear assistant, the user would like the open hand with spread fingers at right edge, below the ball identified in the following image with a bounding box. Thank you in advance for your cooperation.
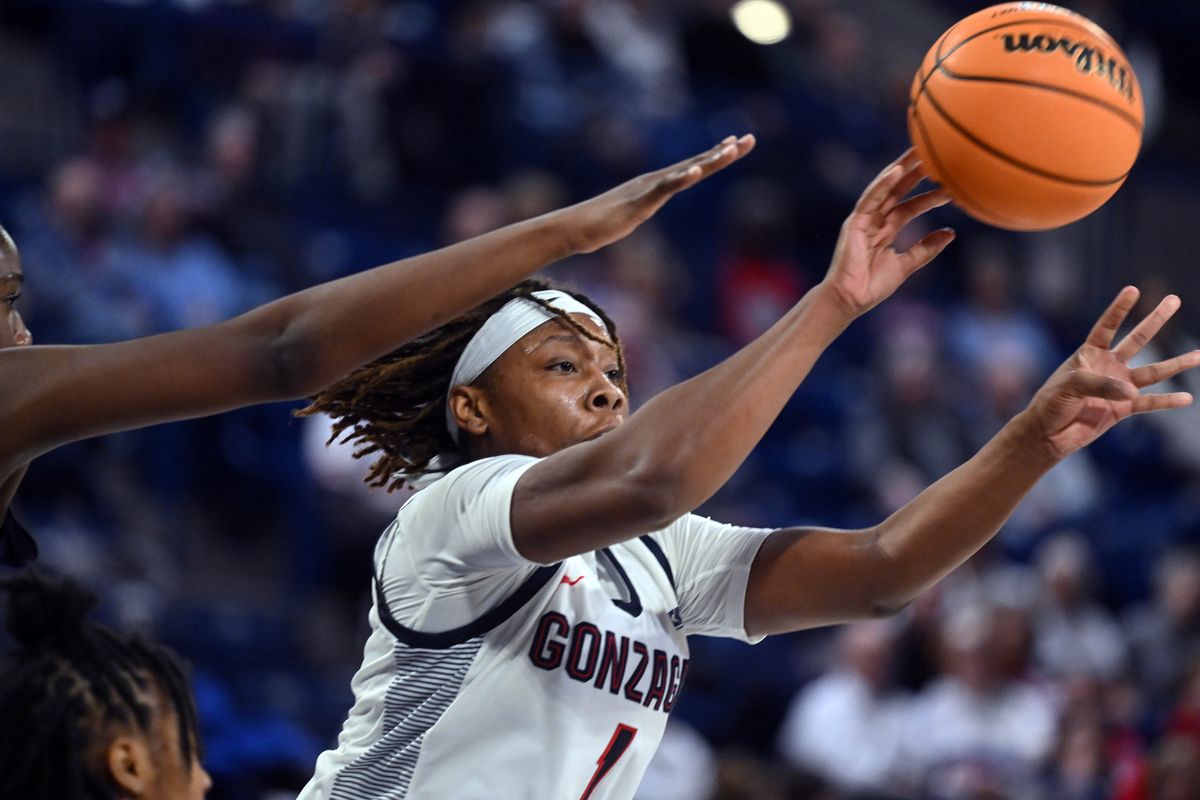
[1026,287,1200,458]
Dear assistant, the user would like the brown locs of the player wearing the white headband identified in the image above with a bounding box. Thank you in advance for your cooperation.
[296,278,629,492]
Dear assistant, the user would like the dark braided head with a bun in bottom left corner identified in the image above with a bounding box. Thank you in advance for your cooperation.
[0,571,211,800]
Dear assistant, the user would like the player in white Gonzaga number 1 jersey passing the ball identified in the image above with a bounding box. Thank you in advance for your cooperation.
[300,152,1200,800]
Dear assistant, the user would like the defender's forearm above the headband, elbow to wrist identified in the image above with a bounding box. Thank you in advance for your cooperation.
[259,209,577,398]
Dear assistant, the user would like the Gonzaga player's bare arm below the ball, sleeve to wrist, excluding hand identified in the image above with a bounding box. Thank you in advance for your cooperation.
[523,280,850,551]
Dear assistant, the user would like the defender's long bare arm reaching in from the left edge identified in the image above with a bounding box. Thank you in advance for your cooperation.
[0,136,755,489]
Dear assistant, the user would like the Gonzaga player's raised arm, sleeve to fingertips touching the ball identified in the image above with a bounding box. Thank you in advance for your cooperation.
[511,151,954,563]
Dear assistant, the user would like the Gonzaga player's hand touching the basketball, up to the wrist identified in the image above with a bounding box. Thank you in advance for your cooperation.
[823,149,954,319]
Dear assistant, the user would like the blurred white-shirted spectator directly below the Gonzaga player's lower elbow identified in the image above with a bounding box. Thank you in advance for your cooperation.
[779,621,910,798]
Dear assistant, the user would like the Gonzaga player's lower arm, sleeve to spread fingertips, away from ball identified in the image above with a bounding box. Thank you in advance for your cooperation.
[745,287,1200,634]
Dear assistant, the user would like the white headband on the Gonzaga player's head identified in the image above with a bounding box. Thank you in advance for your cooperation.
[446,289,607,441]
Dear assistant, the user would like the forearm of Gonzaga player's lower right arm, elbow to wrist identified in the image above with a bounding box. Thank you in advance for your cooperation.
[864,411,1058,610]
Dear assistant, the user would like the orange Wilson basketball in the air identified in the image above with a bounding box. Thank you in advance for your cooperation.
[908,2,1142,230]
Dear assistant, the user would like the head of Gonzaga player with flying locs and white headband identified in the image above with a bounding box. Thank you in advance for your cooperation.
[300,279,629,488]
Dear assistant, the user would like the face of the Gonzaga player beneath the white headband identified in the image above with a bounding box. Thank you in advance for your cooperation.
[470,314,629,456]
